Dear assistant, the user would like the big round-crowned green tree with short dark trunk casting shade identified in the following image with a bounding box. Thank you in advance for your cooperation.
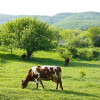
[2,17,55,58]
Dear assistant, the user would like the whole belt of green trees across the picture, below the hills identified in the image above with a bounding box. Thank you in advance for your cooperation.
[0,17,100,59]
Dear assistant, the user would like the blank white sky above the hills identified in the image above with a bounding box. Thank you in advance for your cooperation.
[0,0,100,16]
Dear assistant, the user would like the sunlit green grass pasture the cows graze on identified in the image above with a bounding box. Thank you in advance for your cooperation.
[0,48,100,100]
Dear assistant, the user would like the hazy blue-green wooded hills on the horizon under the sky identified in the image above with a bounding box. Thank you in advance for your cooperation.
[0,12,100,30]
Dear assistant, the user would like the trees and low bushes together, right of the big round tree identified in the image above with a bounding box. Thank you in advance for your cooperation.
[58,26,100,60]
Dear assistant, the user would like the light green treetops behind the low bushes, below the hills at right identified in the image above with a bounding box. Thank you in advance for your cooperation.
[59,26,100,48]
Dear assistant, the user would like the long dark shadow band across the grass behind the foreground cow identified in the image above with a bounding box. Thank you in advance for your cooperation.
[0,54,100,68]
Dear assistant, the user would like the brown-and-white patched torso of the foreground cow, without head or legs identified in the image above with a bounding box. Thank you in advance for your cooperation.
[32,65,61,80]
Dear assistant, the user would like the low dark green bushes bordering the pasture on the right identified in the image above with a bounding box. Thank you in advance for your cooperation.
[57,45,100,61]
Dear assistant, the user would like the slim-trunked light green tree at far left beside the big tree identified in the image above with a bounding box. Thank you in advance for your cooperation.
[0,21,15,54]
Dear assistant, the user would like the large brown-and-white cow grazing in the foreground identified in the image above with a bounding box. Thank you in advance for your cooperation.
[22,65,63,90]
